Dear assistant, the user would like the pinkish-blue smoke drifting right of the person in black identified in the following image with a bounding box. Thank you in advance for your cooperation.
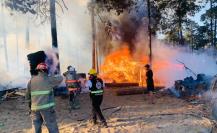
[150,40,217,87]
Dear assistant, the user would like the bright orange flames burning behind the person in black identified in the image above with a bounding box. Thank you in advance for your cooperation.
[100,46,183,86]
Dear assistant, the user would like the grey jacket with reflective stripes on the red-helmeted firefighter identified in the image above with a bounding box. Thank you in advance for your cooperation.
[28,73,63,111]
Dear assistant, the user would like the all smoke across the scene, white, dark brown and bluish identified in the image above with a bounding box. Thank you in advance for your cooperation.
[0,0,216,90]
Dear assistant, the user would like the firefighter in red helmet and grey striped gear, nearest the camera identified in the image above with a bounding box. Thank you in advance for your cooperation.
[26,63,63,133]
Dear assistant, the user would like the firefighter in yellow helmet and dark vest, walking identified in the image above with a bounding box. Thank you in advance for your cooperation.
[87,69,108,128]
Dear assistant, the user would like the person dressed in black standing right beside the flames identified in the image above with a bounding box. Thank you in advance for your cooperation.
[145,64,155,104]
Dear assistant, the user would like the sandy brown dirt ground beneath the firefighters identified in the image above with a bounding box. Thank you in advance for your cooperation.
[0,89,217,133]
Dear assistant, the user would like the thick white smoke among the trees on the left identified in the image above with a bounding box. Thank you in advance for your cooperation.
[0,0,92,88]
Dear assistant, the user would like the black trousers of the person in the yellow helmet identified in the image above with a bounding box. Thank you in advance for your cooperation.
[90,95,106,122]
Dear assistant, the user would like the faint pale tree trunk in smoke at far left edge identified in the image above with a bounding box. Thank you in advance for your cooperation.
[1,0,9,71]
